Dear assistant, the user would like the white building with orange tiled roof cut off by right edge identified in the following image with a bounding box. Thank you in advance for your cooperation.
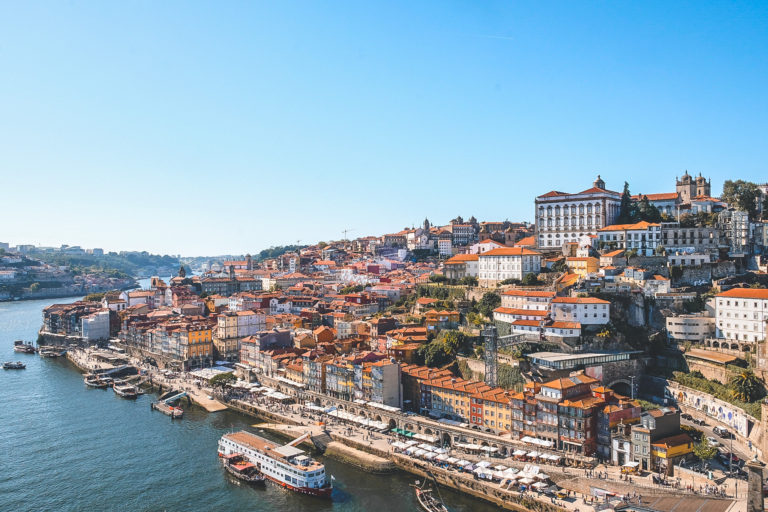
[715,288,768,342]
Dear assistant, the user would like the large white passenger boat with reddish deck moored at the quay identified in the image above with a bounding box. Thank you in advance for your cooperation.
[219,430,333,498]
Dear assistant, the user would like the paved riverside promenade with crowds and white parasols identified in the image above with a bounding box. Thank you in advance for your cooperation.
[63,349,746,512]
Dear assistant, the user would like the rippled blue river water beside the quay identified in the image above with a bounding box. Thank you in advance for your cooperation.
[0,299,497,512]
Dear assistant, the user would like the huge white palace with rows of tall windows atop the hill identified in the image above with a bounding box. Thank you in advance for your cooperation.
[536,176,621,248]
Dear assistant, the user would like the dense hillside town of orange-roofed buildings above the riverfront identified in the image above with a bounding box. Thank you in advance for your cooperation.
[37,171,768,510]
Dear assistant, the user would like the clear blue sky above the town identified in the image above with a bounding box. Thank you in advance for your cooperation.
[0,0,768,255]
